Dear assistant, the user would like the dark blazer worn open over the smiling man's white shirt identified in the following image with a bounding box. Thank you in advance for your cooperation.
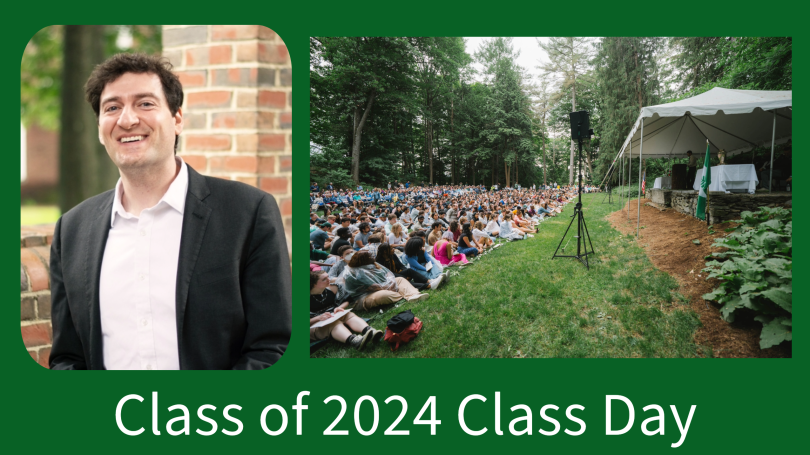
[50,167,292,370]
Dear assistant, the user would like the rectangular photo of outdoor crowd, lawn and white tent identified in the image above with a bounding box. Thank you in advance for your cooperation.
[308,36,793,358]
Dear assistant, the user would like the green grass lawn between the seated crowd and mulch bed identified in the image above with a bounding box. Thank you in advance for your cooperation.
[313,194,700,358]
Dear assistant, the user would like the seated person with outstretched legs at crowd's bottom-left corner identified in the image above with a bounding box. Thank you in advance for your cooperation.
[309,270,383,351]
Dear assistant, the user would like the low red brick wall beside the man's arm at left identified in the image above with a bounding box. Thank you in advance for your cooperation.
[20,225,53,368]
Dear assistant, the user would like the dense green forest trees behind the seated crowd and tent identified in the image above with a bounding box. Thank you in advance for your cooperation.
[310,37,792,191]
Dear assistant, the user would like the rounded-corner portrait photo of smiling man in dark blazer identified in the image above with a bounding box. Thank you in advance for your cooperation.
[20,25,292,370]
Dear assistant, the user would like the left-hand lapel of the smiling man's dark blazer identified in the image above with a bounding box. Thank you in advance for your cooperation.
[82,191,114,370]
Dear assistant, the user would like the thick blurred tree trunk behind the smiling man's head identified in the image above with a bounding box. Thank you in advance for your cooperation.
[59,25,109,213]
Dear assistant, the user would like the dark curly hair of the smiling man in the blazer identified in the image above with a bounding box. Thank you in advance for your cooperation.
[84,54,183,149]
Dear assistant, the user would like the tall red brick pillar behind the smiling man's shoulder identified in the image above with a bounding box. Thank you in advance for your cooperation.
[163,25,292,253]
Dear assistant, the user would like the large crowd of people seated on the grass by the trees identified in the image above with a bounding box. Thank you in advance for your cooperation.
[310,182,576,348]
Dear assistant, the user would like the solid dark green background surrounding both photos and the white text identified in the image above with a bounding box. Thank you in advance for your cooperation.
[0,1,808,453]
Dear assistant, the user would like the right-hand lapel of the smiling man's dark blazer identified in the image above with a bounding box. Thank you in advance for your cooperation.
[175,166,211,360]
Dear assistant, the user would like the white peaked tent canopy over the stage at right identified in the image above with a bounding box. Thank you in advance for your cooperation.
[619,87,793,159]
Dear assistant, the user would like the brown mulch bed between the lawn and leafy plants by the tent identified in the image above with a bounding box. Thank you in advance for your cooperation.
[607,199,791,358]
